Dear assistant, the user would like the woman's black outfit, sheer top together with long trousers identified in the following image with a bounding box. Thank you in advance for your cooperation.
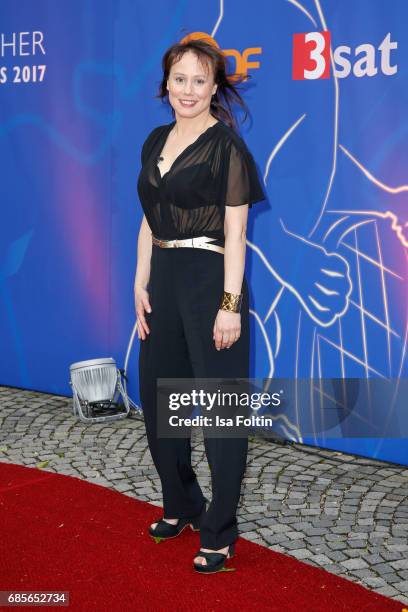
[137,121,265,550]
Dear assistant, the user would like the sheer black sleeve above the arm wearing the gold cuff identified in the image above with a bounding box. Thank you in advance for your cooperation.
[225,144,266,208]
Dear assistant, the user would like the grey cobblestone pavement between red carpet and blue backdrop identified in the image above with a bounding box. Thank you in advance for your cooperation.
[0,387,408,603]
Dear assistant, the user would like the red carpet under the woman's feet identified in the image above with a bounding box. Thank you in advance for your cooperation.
[0,463,404,612]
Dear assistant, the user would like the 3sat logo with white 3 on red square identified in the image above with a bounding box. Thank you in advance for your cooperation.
[292,30,398,80]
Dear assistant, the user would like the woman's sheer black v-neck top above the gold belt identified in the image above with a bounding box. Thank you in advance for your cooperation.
[137,121,266,243]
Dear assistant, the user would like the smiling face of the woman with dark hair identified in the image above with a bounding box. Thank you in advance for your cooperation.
[167,51,217,118]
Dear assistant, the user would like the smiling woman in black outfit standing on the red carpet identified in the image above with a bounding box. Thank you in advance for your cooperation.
[135,40,265,573]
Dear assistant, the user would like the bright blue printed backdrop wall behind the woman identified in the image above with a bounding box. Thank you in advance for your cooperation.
[0,0,408,464]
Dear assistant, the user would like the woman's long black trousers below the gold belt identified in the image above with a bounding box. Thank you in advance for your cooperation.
[139,245,249,550]
